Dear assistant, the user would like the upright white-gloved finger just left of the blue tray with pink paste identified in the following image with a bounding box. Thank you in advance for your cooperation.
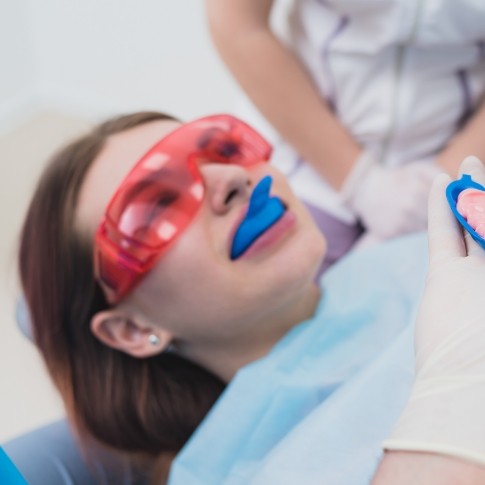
[428,173,467,266]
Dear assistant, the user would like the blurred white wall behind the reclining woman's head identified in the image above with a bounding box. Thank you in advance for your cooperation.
[21,0,242,118]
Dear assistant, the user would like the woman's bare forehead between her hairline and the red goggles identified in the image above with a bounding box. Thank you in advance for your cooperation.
[76,120,180,235]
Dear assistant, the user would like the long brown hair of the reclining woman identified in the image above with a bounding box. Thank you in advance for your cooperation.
[19,112,224,456]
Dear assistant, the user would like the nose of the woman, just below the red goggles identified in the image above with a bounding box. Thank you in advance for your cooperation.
[200,163,252,215]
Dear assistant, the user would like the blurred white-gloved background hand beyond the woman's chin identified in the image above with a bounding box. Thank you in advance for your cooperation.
[340,152,440,239]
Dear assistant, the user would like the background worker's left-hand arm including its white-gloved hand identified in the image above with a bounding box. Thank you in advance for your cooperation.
[205,0,442,239]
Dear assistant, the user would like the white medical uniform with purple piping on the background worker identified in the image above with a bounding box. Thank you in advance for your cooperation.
[242,0,485,223]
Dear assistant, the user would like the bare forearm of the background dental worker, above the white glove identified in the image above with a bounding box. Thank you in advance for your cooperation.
[206,0,362,189]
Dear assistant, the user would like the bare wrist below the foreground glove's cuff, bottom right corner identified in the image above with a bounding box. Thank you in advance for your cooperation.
[372,451,485,485]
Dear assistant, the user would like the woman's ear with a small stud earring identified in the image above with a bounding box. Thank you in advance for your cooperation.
[91,309,172,358]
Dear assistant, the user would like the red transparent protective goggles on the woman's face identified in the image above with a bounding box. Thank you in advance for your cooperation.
[94,115,272,304]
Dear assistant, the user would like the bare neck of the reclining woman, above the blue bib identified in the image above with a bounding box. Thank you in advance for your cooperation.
[182,284,320,382]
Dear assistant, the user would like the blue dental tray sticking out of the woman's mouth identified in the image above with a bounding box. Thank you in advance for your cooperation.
[231,175,285,259]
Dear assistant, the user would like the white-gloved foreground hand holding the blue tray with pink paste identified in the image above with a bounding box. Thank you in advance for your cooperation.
[384,157,485,465]
